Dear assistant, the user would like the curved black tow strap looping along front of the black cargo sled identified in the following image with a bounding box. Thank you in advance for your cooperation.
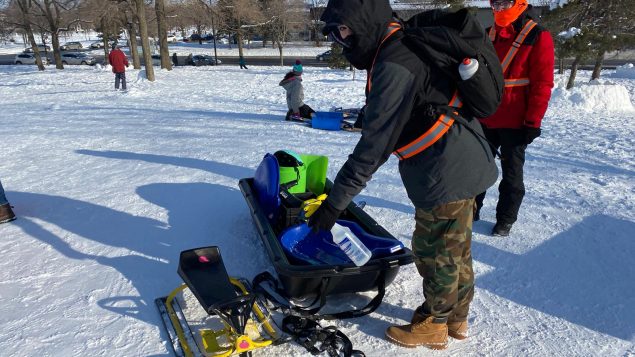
[252,269,386,320]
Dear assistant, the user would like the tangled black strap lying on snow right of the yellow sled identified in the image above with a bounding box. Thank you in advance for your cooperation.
[282,316,366,357]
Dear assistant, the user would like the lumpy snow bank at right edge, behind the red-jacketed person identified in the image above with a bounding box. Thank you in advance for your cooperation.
[550,78,635,112]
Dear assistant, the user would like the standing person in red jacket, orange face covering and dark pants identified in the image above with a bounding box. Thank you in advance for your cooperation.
[474,0,554,236]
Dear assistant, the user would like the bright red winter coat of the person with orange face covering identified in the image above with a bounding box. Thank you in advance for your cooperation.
[480,15,554,129]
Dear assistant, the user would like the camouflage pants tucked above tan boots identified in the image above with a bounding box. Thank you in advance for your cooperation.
[412,198,474,321]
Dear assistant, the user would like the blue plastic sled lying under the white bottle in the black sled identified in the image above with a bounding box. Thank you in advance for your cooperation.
[280,219,404,265]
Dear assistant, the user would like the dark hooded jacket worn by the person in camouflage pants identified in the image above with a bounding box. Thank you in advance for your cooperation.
[321,0,497,210]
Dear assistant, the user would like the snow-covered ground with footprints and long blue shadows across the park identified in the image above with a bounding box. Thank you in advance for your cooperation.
[0,61,635,356]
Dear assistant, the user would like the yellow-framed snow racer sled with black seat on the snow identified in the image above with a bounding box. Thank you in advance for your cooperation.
[156,247,280,357]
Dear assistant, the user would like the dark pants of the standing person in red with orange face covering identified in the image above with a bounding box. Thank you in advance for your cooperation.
[476,127,527,224]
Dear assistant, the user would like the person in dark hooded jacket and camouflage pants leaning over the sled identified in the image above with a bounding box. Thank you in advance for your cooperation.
[309,0,497,349]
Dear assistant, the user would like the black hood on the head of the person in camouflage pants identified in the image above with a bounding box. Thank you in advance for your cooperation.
[320,0,392,69]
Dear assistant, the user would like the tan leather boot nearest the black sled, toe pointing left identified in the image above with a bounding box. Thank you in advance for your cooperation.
[386,316,448,350]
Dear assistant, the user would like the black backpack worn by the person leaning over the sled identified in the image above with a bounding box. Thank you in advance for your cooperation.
[404,9,505,118]
